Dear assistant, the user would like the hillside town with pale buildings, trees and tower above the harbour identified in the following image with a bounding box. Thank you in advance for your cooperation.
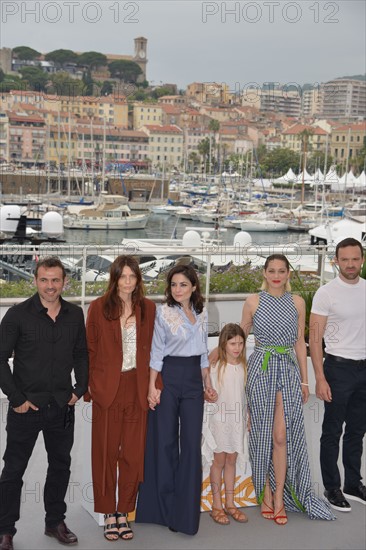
[0,37,366,183]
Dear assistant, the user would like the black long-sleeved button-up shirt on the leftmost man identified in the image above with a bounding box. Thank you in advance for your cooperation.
[0,293,88,407]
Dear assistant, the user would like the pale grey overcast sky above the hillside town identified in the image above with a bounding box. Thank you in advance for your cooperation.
[0,0,366,90]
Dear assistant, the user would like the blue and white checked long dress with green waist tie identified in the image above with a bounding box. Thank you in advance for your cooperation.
[247,291,334,519]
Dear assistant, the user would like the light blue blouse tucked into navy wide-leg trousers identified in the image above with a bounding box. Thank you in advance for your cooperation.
[150,304,209,372]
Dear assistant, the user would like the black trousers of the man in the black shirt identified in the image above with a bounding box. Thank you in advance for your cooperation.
[0,401,75,535]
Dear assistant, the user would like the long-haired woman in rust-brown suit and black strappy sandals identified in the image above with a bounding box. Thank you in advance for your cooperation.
[86,256,160,541]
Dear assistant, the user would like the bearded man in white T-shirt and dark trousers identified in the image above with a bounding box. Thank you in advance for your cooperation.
[310,238,366,512]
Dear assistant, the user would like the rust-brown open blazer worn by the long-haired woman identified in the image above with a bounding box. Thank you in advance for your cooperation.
[84,296,161,411]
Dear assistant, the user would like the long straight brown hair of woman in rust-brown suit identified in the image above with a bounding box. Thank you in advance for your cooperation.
[103,256,145,321]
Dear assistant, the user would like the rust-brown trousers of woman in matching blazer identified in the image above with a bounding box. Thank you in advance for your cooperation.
[92,369,147,514]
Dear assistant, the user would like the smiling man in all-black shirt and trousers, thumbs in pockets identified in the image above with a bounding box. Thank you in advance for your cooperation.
[0,257,88,550]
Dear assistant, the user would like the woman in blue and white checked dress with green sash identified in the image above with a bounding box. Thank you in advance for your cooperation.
[241,254,334,525]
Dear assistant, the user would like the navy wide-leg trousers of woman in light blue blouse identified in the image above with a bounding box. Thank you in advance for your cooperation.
[136,356,203,535]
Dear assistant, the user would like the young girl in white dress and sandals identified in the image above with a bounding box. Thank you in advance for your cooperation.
[203,323,248,525]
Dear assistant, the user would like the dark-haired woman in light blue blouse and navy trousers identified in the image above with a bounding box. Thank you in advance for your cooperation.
[136,265,217,535]
